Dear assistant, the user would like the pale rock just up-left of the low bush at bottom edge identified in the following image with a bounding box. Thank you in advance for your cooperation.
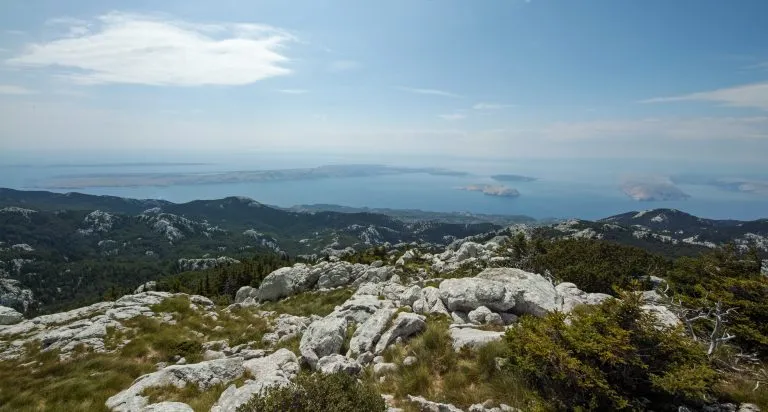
[211,349,299,412]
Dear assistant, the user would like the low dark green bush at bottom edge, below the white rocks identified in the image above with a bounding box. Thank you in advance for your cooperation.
[238,373,386,412]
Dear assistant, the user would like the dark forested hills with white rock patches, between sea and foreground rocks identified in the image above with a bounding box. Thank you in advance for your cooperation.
[0,189,768,309]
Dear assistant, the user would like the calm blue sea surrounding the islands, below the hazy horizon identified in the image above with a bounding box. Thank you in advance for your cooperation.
[0,152,768,220]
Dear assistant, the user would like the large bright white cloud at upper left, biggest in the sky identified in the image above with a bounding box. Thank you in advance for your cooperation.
[6,13,295,86]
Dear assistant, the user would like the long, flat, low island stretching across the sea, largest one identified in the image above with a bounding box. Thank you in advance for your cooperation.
[37,165,467,189]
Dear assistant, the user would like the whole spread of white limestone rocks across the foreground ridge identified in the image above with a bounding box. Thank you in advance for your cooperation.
[0,236,756,412]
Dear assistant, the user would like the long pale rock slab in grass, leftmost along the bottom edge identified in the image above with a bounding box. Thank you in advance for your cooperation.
[106,358,245,412]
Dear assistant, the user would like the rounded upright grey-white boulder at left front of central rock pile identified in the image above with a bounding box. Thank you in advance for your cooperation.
[299,316,347,369]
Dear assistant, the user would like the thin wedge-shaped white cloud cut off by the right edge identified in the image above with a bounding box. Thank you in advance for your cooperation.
[641,82,768,110]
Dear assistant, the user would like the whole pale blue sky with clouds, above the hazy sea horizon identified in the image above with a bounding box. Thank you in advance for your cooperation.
[0,0,768,167]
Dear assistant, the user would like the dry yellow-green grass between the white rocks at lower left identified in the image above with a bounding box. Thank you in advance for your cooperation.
[0,297,272,412]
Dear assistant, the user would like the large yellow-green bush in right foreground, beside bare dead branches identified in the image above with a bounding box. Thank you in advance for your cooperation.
[505,295,717,410]
